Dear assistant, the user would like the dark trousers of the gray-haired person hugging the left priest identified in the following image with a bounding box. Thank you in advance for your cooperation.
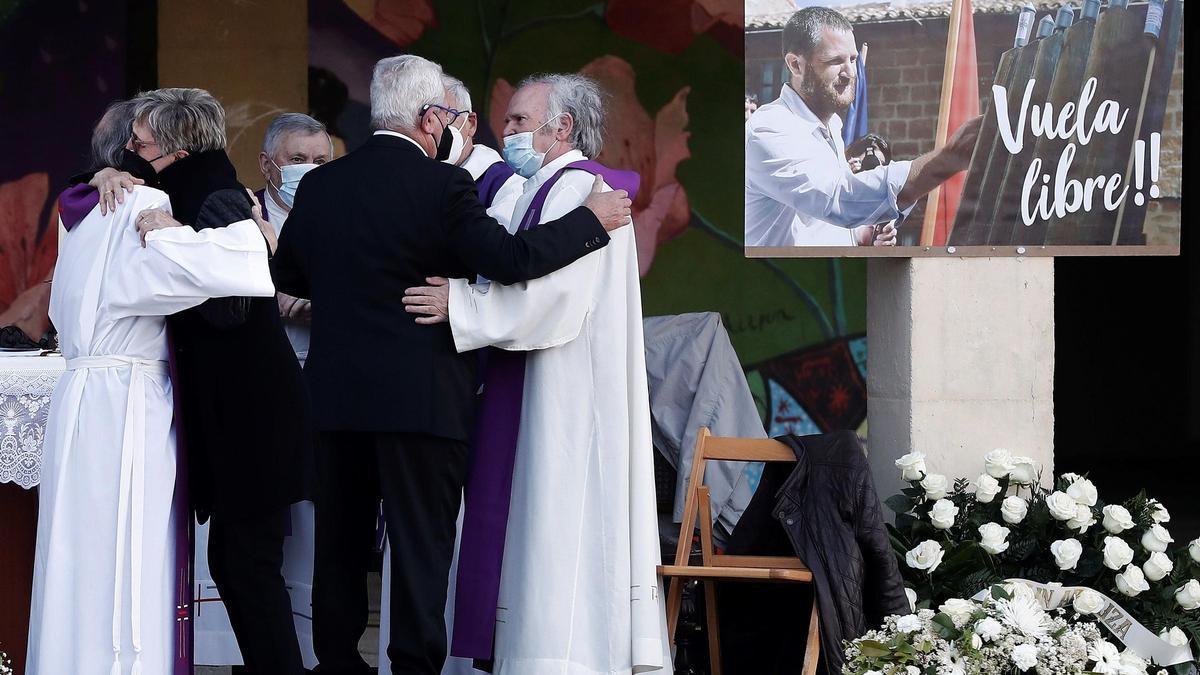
[209,507,304,675]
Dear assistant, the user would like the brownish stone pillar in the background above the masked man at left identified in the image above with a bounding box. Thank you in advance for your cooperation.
[158,0,308,181]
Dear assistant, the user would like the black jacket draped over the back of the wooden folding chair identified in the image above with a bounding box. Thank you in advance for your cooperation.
[727,431,910,675]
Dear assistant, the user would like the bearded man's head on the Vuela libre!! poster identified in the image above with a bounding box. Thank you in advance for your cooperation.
[786,28,858,119]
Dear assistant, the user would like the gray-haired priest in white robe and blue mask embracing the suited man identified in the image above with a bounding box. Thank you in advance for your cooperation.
[404,76,672,675]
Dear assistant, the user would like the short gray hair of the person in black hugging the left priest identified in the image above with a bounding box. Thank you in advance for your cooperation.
[133,88,226,155]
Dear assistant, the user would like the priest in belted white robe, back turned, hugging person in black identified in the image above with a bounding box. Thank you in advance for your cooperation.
[28,103,275,675]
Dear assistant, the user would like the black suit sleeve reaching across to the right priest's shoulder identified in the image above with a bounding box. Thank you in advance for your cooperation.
[441,172,608,285]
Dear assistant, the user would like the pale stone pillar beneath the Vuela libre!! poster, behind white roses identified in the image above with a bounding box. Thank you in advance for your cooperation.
[866,257,1055,498]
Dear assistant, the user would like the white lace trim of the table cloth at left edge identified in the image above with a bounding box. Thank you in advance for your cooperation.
[0,363,62,490]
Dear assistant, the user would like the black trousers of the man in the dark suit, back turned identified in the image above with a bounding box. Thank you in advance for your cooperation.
[312,431,468,675]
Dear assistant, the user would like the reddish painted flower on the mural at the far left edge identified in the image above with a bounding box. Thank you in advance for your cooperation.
[0,173,58,340]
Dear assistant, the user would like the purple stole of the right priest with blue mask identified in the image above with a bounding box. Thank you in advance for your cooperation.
[450,160,641,659]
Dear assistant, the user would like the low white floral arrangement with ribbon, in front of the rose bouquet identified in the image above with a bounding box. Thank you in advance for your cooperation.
[841,585,1148,675]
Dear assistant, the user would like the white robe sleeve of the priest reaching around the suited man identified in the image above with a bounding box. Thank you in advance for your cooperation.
[449,240,608,352]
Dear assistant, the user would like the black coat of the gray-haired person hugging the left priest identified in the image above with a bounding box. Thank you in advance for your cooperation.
[158,150,313,515]
